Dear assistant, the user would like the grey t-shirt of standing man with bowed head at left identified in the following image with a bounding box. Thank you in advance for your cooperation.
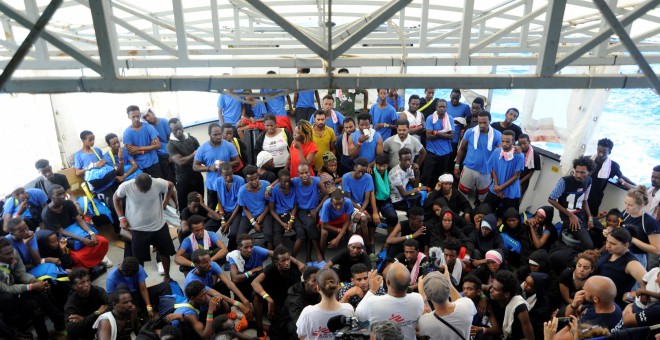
[116,178,168,231]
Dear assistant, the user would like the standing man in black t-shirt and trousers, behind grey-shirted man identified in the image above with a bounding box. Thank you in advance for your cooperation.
[167,118,204,212]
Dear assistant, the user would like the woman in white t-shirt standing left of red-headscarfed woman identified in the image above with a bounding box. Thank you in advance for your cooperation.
[254,115,293,174]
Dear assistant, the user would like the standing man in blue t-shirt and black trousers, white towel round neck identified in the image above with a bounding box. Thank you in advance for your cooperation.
[422,99,454,187]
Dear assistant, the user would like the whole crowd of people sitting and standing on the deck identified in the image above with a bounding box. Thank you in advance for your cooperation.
[0,80,660,340]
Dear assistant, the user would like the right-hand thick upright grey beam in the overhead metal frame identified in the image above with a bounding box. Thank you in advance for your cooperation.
[536,0,566,77]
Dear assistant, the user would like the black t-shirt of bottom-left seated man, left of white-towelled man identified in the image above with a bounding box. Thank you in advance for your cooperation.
[64,285,108,340]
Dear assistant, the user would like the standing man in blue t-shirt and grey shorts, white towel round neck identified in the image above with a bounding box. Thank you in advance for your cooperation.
[454,111,502,202]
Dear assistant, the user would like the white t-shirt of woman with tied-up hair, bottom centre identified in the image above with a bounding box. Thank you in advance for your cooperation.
[296,303,353,339]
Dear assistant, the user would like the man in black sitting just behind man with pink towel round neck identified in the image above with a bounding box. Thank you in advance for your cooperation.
[383,207,429,258]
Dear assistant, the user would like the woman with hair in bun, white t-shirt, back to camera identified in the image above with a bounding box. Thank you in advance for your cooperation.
[296,269,353,339]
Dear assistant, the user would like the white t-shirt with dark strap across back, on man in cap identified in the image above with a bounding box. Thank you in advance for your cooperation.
[419,297,477,340]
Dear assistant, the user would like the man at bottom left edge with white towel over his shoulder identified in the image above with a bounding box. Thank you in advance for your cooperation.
[92,289,141,340]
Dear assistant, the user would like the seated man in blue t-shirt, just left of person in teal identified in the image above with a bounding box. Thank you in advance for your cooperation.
[341,158,379,254]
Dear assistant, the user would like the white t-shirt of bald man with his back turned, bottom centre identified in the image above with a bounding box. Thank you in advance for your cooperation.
[355,291,424,339]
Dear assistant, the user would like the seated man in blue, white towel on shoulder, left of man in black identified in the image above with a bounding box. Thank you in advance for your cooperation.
[227,234,273,297]
